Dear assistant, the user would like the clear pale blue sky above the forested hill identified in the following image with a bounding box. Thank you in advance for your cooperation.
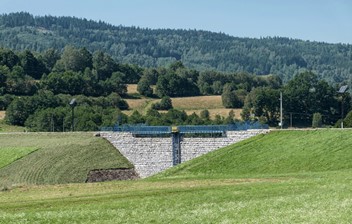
[0,0,352,44]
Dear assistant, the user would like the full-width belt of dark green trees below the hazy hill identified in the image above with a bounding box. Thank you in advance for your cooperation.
[0,46,352,131]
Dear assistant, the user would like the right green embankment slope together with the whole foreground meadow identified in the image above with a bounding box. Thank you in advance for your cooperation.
[0,130,352,223]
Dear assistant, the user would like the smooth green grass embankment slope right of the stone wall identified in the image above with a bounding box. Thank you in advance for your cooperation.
[155,129,352,178]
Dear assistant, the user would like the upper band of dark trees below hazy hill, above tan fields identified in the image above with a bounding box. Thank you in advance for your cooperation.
[0,46,282,97]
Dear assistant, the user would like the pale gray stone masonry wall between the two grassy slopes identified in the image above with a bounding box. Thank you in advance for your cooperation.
[100,129,269,178]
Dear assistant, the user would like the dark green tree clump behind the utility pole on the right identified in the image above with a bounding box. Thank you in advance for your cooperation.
[242,72,351,127]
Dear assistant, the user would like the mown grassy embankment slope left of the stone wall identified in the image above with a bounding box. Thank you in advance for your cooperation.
[0,133,132,188]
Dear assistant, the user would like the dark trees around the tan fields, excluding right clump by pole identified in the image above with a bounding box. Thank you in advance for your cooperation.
[0,46,281,131]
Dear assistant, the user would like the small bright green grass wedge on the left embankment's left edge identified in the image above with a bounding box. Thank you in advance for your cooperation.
[0,147,38,169]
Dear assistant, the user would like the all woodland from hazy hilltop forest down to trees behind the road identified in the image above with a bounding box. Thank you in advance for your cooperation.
[0,13,352,131]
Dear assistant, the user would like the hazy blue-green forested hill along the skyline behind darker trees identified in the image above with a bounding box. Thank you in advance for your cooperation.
[0,12,352,83]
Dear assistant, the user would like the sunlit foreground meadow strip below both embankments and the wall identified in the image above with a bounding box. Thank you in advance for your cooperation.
[0,171,352,223]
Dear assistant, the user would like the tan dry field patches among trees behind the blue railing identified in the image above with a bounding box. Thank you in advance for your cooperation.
[123,84,242,119]
